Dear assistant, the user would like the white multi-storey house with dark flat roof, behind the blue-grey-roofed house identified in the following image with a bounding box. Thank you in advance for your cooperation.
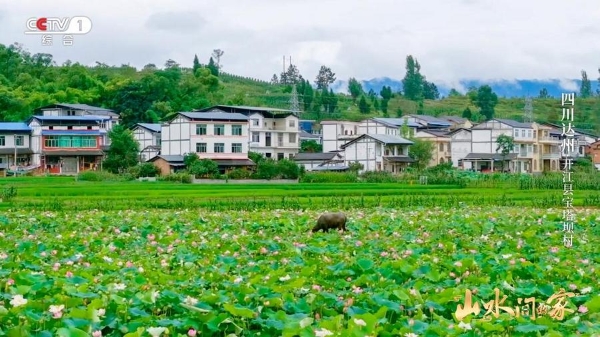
[197,105,300,160]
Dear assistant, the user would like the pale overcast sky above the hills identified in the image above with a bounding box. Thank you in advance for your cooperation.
[0,0,600,85]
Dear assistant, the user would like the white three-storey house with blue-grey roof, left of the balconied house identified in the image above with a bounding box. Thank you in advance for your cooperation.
[158,112,255,172]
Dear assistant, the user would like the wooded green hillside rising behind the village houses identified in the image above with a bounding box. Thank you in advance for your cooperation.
[0,44,600,132]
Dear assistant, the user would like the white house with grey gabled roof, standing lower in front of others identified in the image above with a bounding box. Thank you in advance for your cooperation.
[342,134,414,173]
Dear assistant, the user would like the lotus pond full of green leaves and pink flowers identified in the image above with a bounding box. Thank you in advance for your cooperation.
[0,207,600,337]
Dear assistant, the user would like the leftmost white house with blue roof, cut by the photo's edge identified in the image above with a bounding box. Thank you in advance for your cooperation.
[0,122,32,171]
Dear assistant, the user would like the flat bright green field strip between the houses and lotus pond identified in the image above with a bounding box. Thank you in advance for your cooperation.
[0,177,600,210]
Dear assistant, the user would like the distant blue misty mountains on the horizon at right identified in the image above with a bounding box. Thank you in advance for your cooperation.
[331,77,599,98]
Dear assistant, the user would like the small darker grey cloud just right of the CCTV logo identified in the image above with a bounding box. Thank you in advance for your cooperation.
[146,12,206,34]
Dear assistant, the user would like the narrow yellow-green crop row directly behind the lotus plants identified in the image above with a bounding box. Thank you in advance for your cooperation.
[4,193,600,211]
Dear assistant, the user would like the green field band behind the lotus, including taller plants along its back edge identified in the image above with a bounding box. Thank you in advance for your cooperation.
[0,172,600,211]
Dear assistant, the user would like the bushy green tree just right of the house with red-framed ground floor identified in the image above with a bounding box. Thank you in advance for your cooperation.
[102,124,140,173]
